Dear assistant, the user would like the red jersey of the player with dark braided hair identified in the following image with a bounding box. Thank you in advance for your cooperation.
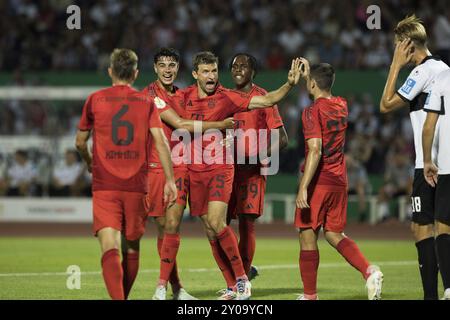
[234,85,283,157]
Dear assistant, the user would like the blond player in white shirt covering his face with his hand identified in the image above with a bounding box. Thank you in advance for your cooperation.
[380,15,449,300]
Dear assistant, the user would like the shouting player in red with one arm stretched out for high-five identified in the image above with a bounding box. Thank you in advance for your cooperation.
[178,52,300,300]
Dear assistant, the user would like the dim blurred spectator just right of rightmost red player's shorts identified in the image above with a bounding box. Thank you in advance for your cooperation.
[345,153,372,222]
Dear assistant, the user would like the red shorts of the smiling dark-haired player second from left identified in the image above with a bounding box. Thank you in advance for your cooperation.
[145,167,189,217]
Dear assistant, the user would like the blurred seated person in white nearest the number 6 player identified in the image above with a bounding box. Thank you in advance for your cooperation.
[49,150,83,197]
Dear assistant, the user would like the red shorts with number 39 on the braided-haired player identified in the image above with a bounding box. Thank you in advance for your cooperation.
[228,166,266,219]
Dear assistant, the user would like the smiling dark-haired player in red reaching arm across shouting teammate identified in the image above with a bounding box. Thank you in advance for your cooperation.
[142,48,234,300]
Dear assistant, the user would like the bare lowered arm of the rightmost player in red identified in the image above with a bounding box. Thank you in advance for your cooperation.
[295,138,322,209]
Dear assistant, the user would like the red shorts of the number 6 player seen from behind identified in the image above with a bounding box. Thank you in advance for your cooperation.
[92,190,147,241]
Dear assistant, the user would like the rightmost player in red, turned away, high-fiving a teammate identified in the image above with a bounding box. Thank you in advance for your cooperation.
[295,58,383,300]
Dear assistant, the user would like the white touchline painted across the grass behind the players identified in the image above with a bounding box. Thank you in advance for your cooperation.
[0,260,417,277]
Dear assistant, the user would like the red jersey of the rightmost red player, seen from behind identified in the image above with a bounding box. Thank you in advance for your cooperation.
[301,97,348,185]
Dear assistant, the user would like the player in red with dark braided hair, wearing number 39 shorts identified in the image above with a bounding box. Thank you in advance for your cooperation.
[218,53,288,299]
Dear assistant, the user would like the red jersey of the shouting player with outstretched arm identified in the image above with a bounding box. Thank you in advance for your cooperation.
[180,84,251,171]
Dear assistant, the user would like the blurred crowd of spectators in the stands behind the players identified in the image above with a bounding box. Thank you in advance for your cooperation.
[0,0,450,221]
